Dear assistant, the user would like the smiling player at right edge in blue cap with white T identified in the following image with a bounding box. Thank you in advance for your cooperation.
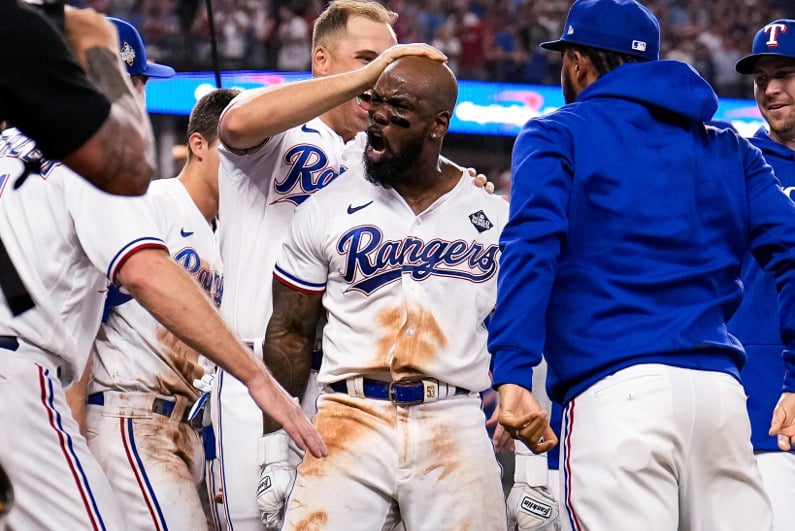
[729,20,795,531]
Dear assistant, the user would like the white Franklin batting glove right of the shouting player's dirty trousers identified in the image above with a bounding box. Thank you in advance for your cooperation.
[506,441,562,531]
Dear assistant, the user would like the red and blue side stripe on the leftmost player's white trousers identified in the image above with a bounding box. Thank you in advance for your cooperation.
[36,365,106,530]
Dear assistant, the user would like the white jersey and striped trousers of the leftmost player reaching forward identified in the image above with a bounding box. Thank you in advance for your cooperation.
[0,130,165,529]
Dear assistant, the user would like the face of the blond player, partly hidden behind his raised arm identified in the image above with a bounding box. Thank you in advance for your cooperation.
[327,17,397,134]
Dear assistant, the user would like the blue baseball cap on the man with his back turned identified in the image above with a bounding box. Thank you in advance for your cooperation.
[541,0,660,61]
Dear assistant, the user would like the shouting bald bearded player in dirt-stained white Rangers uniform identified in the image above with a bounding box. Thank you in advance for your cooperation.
[264,52,507,531]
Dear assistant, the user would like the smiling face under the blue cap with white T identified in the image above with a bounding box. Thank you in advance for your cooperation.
[753,57,795,149]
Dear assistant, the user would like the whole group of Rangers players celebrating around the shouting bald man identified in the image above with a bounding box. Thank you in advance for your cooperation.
[0,0,795,531]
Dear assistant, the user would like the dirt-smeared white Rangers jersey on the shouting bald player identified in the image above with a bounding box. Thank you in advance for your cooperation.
[274,171,508,391]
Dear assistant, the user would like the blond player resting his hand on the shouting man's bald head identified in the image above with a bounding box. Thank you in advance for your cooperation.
[211,0,436,531]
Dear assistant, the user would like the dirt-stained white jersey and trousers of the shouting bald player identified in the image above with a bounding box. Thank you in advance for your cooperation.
[274,166,508,531]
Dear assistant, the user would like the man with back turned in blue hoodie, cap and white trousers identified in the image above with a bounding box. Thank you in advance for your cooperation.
[489,0,795,531]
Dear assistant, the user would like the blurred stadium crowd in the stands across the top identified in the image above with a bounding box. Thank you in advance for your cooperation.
[70,0,795,97]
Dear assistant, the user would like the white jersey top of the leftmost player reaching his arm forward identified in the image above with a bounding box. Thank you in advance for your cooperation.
[0,129,166,385]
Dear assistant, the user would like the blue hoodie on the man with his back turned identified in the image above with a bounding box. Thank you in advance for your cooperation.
[489,61,795,404]
